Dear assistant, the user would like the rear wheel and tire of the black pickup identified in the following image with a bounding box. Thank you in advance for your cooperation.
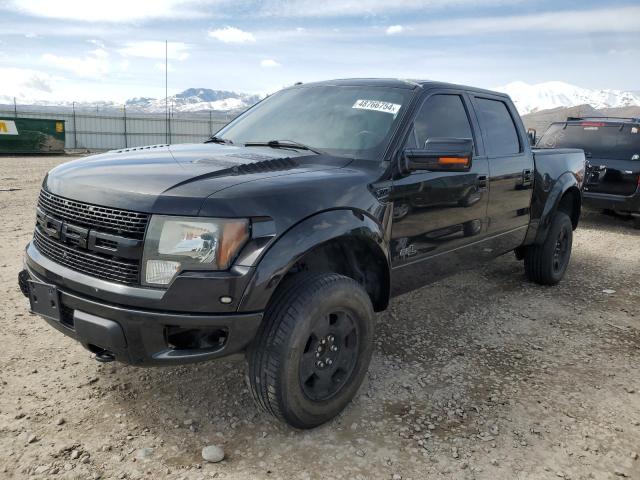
[524,212,573,285]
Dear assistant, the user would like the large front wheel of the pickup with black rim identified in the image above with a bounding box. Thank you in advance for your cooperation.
[248,273,375,429]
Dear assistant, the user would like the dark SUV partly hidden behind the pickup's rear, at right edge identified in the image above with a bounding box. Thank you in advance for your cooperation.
[538,117,640,228]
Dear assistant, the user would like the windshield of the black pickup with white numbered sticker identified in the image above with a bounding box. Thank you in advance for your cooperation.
[216,86,413,161]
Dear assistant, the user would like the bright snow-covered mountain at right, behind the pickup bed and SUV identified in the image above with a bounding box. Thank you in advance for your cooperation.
[495,82,640,115]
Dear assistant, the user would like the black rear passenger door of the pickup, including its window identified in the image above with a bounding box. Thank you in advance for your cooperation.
[472,94,534,246]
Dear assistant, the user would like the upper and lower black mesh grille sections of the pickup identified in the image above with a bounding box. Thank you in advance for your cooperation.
[33,189,150,285]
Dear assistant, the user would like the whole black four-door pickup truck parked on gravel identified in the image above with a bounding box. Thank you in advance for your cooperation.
[19,79,585,428]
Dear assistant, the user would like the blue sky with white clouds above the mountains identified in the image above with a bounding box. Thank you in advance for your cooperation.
[0,0,640,102]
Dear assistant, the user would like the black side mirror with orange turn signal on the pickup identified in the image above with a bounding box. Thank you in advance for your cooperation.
[402,138,473,172]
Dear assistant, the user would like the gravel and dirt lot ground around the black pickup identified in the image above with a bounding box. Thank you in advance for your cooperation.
[0,157,640,480]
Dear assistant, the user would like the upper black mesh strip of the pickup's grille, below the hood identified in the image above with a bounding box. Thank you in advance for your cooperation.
[38,189,149,239]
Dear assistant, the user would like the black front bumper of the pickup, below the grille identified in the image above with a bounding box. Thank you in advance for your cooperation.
[19,244,262,366]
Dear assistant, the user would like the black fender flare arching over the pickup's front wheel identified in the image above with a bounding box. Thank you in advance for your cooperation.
[238,209,391,312]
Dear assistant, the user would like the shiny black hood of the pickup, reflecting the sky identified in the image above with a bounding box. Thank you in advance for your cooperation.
[43,143,350,215]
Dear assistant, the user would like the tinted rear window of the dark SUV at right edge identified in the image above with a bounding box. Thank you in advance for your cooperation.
[538,122,640,160]
